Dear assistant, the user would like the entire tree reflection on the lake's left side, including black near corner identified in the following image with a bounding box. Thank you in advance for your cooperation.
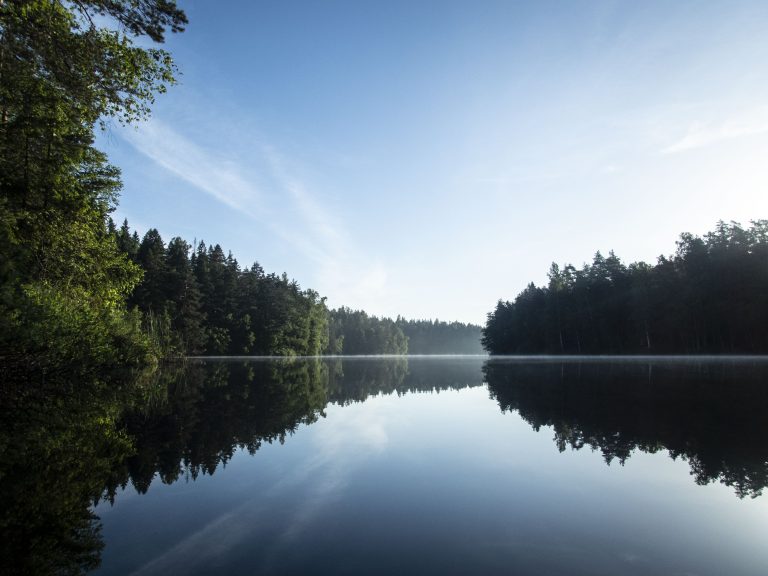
[0,358,482,574]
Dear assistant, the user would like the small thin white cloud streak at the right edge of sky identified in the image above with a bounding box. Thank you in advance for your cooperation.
[661,107,768,154]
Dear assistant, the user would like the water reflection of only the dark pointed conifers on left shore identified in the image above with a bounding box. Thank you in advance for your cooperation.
[114,360,328,492]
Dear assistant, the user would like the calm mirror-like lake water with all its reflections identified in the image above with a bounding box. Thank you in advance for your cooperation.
[0,358,768,576]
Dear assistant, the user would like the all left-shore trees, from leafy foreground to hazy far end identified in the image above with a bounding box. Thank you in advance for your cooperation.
[0,0,481,371]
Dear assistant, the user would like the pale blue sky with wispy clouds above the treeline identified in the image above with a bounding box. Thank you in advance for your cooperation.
[99,0,768,323]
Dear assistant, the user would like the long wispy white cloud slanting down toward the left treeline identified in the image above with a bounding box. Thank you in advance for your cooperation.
[123,119,388,309]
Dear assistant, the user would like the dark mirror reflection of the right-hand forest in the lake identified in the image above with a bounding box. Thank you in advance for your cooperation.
[483,361,768,497]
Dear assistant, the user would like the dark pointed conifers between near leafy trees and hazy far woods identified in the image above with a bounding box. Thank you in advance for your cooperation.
[111,222,328,356]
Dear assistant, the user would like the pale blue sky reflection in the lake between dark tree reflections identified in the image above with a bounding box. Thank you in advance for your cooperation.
[97,386,768,574]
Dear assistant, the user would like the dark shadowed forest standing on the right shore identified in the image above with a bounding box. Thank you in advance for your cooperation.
[482,220,768,354]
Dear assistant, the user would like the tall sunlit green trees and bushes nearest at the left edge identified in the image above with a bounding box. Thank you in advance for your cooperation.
[0,0,186,376]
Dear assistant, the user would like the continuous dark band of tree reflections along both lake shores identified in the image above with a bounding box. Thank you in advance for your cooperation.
[0,356,768,573]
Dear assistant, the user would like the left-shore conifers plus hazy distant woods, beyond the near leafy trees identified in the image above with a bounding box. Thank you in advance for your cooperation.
[108,220,483,356]
